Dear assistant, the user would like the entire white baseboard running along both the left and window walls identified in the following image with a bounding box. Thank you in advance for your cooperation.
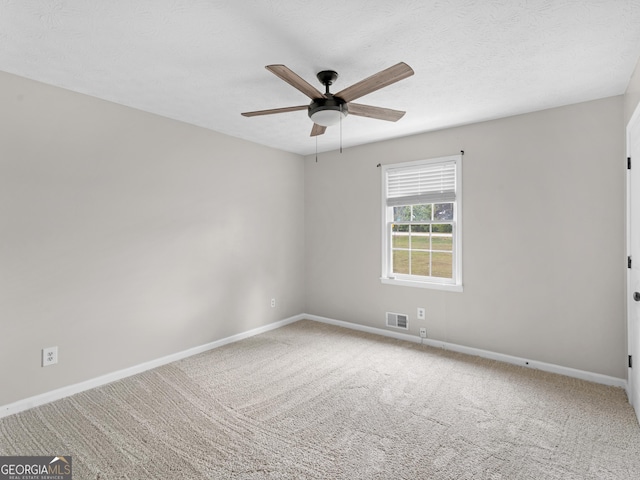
[0,314,628,418]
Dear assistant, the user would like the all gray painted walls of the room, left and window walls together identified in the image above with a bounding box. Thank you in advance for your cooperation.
[0,67,640,405]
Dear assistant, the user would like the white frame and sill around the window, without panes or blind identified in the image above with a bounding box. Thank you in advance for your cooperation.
[380,154,462,292]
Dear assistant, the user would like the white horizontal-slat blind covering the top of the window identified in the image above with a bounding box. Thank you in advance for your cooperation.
[386,161,456,207]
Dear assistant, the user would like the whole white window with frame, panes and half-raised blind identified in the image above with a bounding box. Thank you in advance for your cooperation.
[381,155,462,291]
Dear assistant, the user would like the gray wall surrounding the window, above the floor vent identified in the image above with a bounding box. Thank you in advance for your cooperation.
[305,96,626,378]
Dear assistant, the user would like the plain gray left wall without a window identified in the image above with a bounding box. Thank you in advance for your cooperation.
[0,73,304,405]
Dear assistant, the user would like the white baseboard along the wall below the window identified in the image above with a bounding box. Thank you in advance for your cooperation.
[302,315,627,390]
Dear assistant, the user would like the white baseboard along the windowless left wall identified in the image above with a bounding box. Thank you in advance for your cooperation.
[0,315,306,418]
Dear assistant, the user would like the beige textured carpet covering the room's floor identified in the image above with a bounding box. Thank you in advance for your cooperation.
[0,321,640,480]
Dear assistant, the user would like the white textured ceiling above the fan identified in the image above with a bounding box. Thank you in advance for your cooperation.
[0,0,640,154]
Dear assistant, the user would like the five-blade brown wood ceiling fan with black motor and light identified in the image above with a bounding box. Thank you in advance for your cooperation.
[242,62,414,137]
